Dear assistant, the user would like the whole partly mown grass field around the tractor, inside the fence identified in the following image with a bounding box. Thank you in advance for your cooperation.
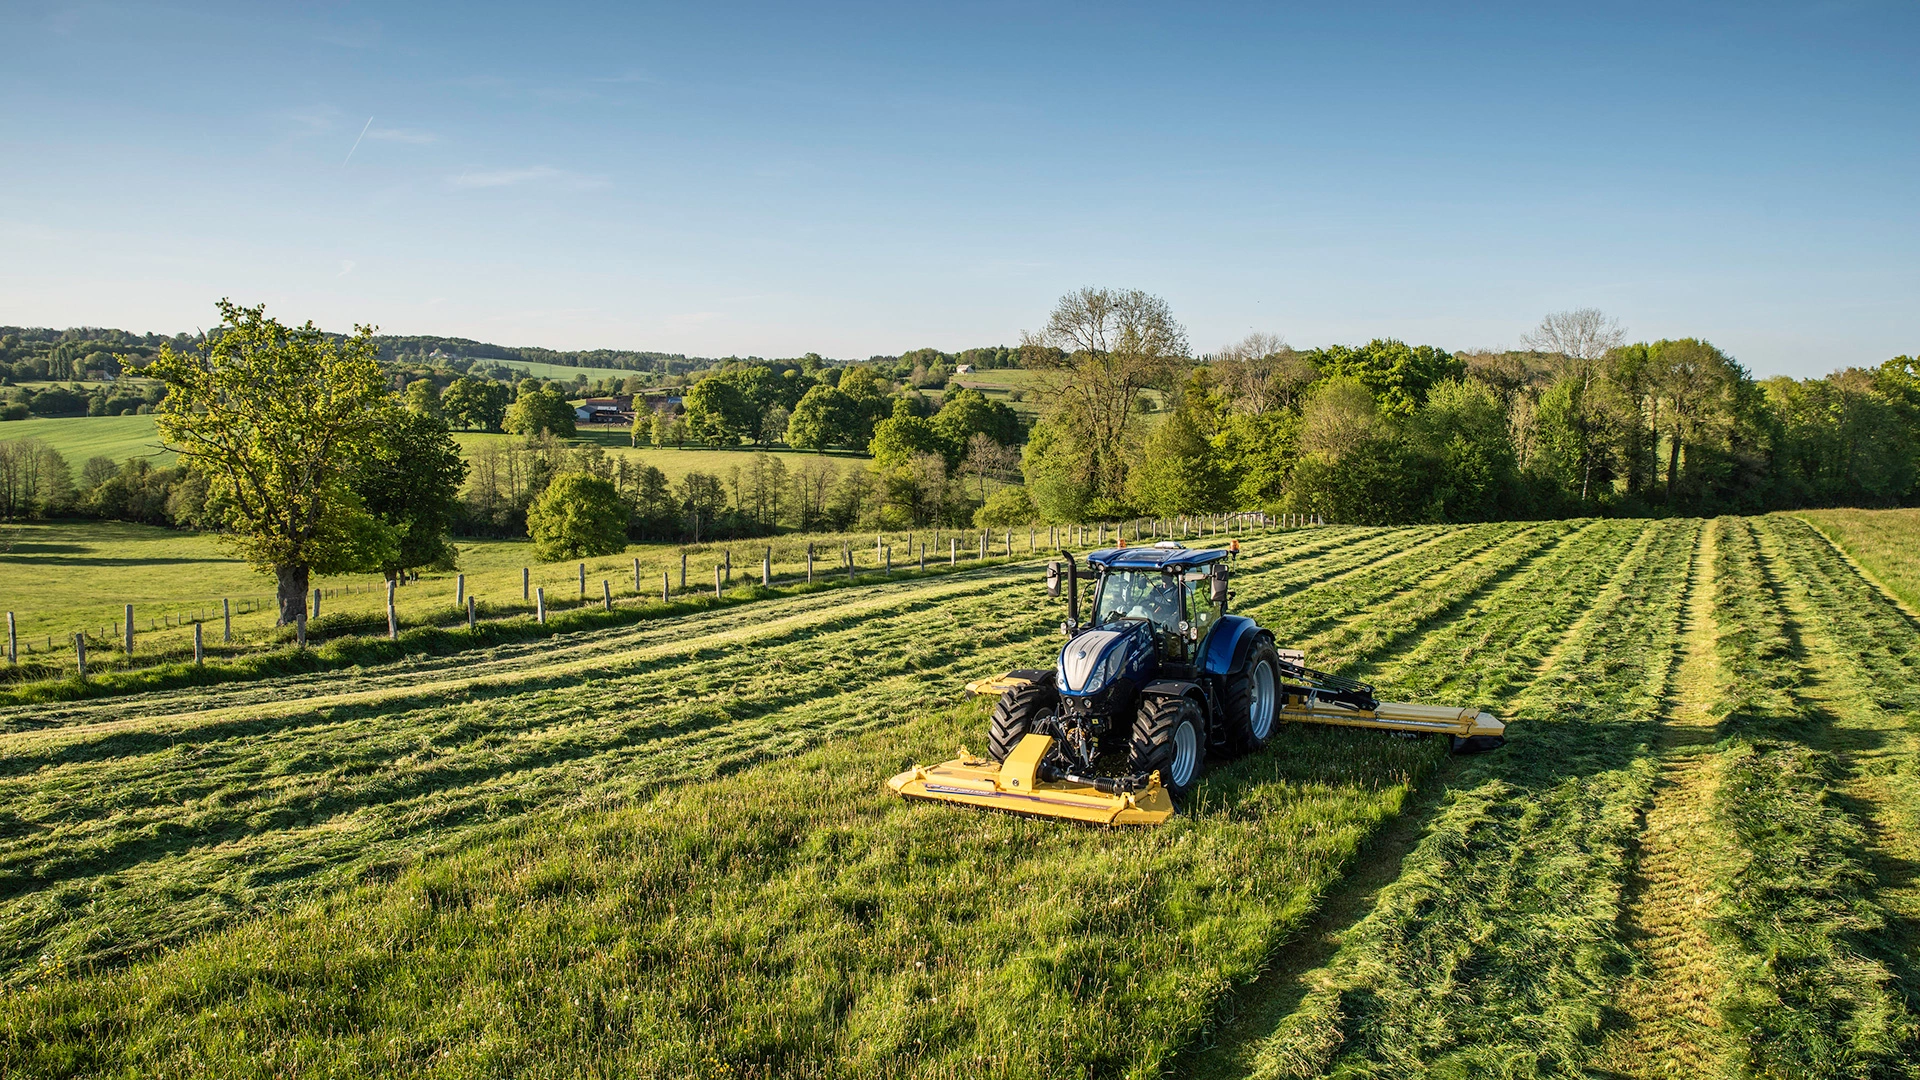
[0,517,1920,1076]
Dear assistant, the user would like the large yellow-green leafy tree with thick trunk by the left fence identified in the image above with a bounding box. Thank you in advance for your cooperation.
[146,300,399,625]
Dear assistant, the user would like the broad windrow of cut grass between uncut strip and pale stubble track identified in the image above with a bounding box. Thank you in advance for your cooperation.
[1252,521,1697,1076]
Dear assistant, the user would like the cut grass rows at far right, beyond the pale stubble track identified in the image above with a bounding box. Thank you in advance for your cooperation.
[1715,521,1920,1076]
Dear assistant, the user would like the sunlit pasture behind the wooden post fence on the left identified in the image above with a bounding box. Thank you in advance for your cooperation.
[0,511,1082,678]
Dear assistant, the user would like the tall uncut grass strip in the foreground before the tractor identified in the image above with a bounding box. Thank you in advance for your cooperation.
[0,522,1512,1076]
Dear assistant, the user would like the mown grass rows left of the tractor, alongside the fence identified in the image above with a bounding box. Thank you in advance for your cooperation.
[0,526,1413,972]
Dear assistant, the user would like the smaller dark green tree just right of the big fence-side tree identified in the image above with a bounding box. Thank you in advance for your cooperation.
[357,409,467,580]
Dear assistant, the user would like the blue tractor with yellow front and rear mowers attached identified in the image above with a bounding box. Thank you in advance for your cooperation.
[887,542,1505,824]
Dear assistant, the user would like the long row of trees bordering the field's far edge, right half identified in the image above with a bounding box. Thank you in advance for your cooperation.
[996,290,1920,523]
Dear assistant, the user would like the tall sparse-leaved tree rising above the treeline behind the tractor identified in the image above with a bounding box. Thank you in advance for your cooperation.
[1020,288,1188,498]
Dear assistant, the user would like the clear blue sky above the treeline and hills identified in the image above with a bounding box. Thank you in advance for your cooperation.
[0,0,1920,375]
